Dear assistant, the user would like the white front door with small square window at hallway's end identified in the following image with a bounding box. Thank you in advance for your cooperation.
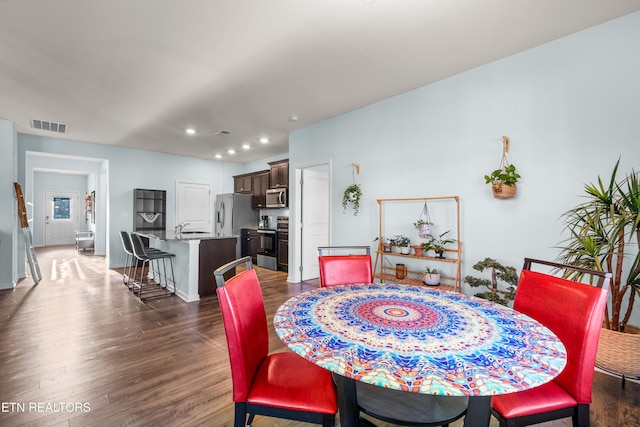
[44,191,82,246]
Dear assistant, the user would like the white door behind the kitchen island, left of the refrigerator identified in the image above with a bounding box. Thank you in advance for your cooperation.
[176,182,211,233]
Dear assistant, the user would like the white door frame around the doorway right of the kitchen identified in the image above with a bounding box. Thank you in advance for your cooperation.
[287,159,333,283]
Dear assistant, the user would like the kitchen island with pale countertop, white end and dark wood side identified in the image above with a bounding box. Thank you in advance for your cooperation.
[133,231,237,302]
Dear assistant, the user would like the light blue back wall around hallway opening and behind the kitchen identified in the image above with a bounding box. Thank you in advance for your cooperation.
[18,134,246,268]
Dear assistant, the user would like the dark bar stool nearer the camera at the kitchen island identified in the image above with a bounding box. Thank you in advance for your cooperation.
[129,234,176,299]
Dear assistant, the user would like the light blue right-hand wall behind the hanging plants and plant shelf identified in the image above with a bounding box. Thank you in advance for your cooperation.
[289,13,640,308]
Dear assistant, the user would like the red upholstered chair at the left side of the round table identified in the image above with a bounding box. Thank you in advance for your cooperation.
[214,257,338,427]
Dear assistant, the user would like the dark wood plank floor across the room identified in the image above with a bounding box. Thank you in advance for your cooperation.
[0,247,640,427]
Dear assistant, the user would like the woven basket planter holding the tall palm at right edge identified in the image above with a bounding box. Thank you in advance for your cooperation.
[596,325,640,378]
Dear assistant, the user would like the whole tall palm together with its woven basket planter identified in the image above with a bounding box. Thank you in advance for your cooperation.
[559,160,640,376]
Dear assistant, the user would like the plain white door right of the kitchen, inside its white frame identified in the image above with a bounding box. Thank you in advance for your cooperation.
[300,169,329,280]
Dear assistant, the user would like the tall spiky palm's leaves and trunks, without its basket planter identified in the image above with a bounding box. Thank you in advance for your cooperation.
[559,160,640,332]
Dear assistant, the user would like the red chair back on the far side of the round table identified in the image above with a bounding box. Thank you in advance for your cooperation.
[318,246,373,288]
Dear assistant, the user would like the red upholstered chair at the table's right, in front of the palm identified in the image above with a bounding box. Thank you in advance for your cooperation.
[491,258,611,427]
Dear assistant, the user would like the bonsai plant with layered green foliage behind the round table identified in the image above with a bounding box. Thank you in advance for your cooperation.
[464,258,518,305]
